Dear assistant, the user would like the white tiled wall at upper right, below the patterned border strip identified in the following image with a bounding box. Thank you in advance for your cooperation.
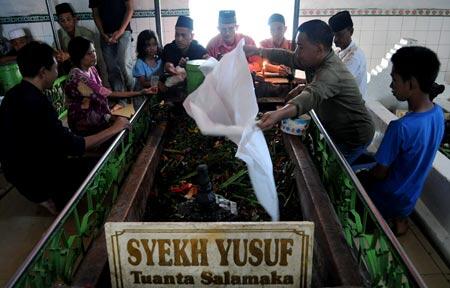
[299,16,450,83]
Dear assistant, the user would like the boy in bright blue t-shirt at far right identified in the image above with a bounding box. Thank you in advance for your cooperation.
[367,47,444,235]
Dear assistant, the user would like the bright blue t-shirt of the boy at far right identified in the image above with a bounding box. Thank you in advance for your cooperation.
[370,104,444,218]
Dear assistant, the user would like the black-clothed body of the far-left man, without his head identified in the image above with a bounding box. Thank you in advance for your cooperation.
[0,70,85,209]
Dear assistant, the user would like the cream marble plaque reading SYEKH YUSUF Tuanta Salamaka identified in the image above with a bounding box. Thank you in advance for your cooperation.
[105,222,314,287]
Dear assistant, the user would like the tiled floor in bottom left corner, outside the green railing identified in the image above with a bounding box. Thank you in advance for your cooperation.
[0,174,54,287]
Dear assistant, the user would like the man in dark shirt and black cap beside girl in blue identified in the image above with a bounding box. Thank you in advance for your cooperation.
[163,16,209,75]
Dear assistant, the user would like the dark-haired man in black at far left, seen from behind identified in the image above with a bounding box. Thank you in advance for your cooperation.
[0,42,84,176]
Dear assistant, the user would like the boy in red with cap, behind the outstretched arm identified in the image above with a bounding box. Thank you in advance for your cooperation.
[260,13,292,76]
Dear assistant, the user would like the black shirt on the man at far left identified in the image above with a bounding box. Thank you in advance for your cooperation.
[0,81,75,182]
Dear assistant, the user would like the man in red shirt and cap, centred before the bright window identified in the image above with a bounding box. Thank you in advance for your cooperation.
[206,10,261,72]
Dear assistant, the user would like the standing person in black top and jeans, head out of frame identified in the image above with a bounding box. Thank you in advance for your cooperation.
[89,0,134,91]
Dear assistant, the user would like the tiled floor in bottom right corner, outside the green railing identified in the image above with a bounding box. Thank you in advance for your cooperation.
[398,221,450,288]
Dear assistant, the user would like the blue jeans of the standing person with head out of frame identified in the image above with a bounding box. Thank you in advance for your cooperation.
[100,31,134,91]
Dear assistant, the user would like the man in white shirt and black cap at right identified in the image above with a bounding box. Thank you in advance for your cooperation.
[328,11,367,97]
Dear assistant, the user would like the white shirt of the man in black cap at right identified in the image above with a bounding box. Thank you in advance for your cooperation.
[338,41,367,97]
